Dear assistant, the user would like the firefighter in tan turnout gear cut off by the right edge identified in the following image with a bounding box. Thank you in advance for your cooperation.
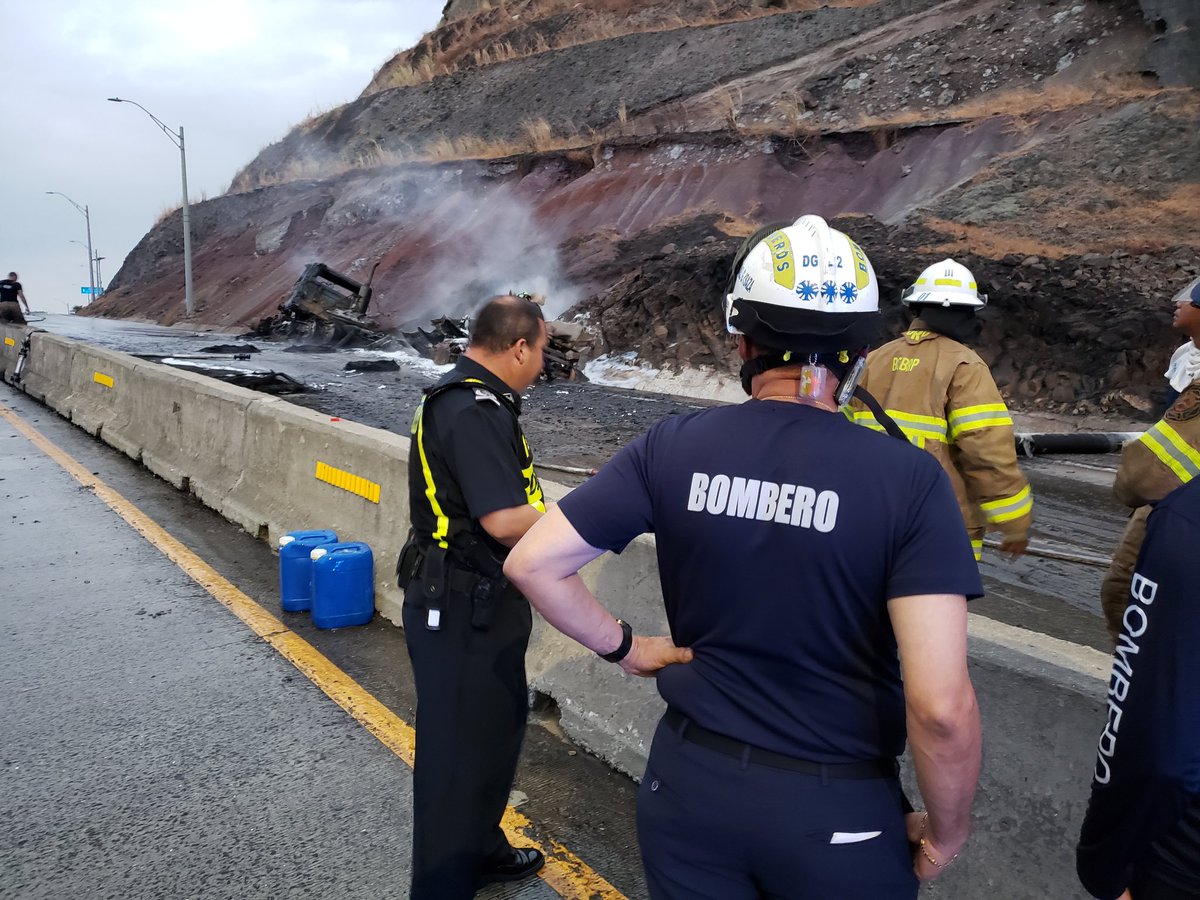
[1100,280,1200,641]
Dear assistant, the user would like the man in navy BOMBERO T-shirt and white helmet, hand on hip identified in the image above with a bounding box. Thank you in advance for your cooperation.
[505,216,982,900]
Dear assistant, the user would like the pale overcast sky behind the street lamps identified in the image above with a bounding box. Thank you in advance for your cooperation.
[0,0,444,312]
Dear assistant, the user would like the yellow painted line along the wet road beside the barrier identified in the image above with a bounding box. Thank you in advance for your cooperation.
[0,403,626,900]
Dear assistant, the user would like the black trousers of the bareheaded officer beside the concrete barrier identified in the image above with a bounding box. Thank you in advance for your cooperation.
[404,578,533,900]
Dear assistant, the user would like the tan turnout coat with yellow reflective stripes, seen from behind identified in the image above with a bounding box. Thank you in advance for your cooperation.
[850,319,1033,540]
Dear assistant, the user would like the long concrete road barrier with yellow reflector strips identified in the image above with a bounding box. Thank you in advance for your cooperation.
[9,329,1108,900]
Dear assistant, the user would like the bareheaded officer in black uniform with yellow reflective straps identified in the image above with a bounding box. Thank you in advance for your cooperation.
[397,296,546,900]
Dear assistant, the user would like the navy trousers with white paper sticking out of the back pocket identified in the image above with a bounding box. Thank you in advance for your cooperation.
[637,722,919,900]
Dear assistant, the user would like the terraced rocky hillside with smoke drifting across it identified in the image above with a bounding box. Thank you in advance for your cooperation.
[90,0,1200,414]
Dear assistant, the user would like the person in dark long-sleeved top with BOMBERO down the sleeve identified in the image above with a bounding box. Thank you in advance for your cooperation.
[1075,480,1200,900]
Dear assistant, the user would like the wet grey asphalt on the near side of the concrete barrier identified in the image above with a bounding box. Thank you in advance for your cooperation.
[0,386,646,900]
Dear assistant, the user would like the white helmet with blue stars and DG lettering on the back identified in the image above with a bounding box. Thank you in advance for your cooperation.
[725,216,880,352]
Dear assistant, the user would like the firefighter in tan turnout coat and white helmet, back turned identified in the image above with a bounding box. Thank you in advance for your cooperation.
[851,259,1033,560]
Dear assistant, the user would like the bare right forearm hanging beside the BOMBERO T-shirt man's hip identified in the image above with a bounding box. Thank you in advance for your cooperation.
[908,688,982,853]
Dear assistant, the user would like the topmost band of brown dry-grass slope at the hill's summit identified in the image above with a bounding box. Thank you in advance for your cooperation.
[362,0,878,96]
